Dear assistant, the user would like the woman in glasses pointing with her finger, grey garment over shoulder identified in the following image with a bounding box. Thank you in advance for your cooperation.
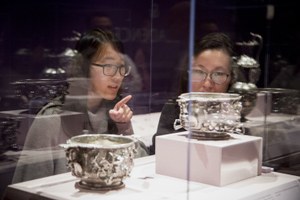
[13,28,148,182]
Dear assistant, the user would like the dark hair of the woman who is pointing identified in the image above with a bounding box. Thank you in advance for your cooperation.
[75,28,124,77]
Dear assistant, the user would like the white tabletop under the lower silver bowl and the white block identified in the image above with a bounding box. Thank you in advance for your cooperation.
[3,156,300,200]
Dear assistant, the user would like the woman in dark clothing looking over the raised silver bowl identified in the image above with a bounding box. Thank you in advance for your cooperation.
[150,32,234,154]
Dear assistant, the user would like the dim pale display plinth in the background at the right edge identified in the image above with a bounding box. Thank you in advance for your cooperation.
[244,113,300,161]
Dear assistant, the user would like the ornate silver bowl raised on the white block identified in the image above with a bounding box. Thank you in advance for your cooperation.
[174,92,242,139]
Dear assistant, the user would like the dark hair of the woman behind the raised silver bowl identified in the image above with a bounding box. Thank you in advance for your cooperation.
[179,32,234,94]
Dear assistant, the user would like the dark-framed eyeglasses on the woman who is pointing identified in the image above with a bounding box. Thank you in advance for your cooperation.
[92,63,131,76]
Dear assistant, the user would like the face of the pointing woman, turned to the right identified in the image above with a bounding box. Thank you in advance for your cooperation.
[90,44,125,100]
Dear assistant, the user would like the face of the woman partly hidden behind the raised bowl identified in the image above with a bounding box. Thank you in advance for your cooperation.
[191,50,231,92]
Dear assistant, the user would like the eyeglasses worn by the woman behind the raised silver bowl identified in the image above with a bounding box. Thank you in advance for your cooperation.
[191,69,229,84]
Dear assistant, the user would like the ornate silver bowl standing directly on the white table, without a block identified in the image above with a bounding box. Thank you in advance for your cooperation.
[60,134,136,190]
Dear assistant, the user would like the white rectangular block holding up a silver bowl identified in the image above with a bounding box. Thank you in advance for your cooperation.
[155,131,262,186]
